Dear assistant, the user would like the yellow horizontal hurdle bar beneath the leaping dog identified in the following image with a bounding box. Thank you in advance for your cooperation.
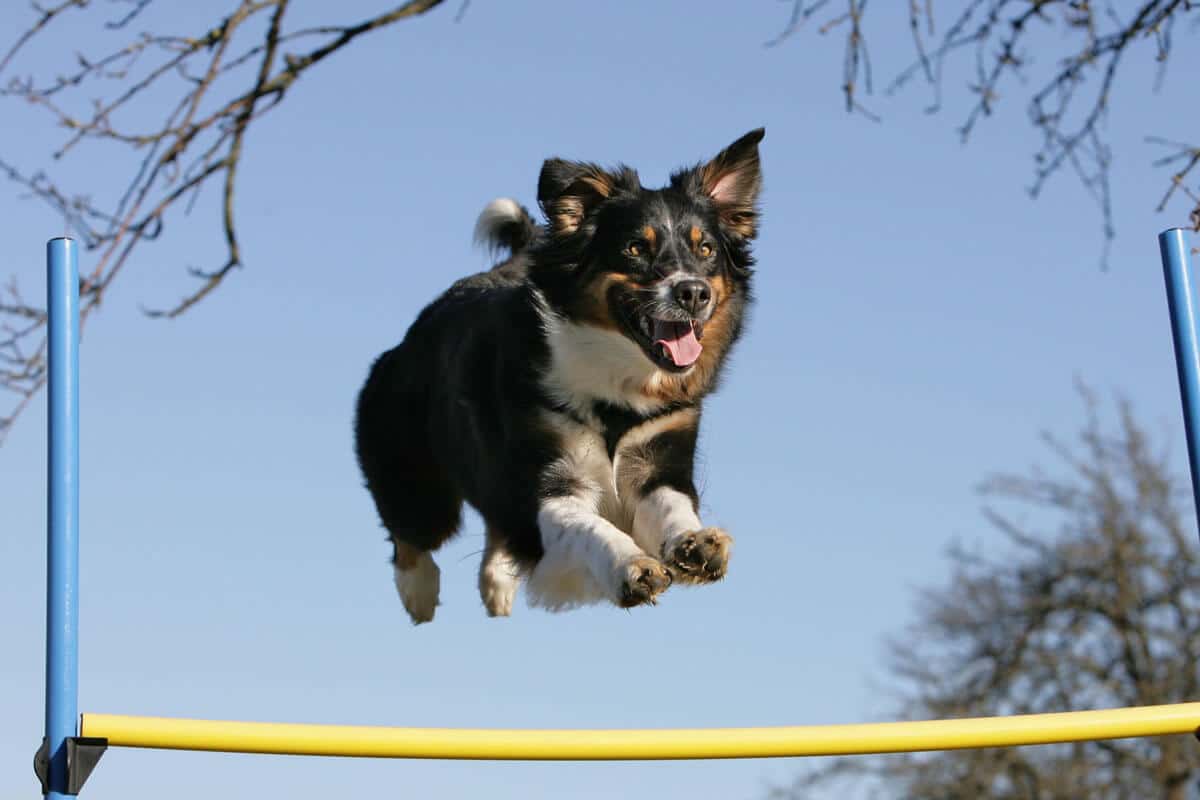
[80,703,1200,760]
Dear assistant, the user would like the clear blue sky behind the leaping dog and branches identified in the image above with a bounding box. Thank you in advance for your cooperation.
[0,0,1200,800]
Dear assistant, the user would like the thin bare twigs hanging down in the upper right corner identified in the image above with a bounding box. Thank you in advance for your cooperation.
[768,0,1200,262]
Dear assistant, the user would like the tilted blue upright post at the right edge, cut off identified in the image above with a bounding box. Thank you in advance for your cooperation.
[1158,228,1200,542]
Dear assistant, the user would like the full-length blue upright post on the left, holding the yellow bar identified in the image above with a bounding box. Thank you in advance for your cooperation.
[46,239,79,800]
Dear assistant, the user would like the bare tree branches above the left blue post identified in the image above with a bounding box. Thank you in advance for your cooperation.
[0,0,443,441]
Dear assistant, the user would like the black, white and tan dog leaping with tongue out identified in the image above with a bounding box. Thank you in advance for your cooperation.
[354,128,764,624]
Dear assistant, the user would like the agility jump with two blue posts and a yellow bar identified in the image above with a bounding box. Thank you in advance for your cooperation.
[35,228,1200,799]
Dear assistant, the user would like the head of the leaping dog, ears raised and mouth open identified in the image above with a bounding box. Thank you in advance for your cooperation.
[534,128,763,389]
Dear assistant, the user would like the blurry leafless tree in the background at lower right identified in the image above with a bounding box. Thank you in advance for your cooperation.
[773,390,1200,800]
